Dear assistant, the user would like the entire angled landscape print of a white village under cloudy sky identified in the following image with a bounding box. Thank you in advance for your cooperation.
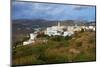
[11,0,96,67]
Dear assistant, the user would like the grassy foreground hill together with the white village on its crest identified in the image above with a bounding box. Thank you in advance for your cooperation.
[12,22,96,65]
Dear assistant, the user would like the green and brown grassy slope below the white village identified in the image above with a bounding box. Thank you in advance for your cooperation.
[13,32,96,65]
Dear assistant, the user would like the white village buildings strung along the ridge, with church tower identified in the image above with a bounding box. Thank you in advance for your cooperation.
[23,22,95,45]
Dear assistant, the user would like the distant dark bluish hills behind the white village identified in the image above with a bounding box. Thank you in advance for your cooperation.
[12,19,95,34]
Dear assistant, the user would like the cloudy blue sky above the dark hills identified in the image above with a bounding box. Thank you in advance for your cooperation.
[12,1,95,21]
